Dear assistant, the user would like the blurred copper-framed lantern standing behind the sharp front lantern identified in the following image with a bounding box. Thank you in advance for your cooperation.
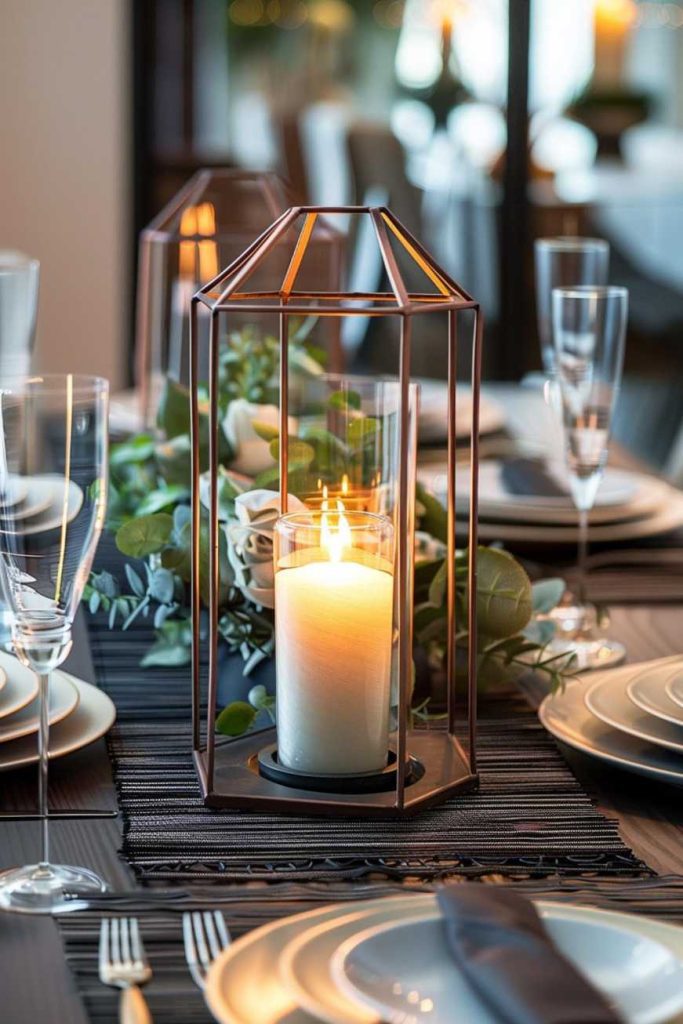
[135,168,342,428]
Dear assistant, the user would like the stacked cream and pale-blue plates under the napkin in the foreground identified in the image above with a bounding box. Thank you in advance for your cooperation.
[206,895,683,1024]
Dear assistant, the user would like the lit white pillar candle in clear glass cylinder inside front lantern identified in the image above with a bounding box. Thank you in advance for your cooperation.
[274,512,394,775]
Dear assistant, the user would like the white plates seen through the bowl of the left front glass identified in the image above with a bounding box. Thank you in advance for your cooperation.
[0,473,83,536]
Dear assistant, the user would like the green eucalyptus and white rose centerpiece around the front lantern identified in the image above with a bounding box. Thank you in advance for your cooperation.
[85,322,571,735]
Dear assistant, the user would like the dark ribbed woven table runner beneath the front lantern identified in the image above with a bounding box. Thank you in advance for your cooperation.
[82,589,648,884]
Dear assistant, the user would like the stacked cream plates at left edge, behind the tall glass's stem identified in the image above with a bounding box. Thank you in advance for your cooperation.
[0,651,116,771]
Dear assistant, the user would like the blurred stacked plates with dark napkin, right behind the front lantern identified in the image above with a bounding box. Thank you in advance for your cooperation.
[419,459,683,544]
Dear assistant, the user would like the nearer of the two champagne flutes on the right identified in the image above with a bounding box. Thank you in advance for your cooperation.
[552,286,629,669]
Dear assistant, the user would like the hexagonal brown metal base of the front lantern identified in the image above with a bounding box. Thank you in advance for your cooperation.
[195,728,479,818]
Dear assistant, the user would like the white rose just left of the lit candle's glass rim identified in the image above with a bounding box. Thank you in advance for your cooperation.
[225,489,306,608]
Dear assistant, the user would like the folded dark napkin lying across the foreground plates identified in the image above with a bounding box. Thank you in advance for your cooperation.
[436,884,620,1024]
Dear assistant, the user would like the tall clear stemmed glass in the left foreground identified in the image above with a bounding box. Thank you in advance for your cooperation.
[0,374,109,913]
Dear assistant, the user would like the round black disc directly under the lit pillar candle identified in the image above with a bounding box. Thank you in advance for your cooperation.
[257,743,424,794]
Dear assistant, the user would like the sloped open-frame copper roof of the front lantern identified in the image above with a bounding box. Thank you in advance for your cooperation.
[195,200,477,316]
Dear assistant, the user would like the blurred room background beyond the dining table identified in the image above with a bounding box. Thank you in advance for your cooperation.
[0,0,683,467]
